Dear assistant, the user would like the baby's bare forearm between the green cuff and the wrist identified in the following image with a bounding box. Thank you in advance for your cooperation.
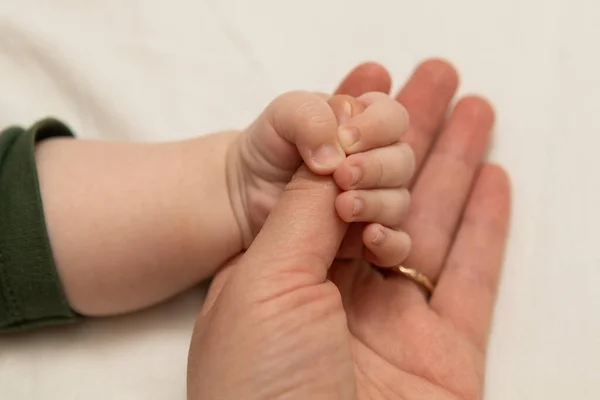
[36,133,242,316]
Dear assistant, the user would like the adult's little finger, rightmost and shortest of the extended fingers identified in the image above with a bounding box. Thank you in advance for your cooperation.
[430,165,510,350]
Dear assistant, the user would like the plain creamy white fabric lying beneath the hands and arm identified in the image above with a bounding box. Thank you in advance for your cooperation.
[0,0,600,400]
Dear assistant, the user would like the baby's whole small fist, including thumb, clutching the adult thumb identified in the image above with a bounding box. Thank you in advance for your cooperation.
[228,92,414,266]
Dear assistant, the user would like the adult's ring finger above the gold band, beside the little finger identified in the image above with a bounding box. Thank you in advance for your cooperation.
[403,97,494,290]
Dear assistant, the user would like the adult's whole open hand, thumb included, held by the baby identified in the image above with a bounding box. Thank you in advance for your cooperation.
[188,60,510,400]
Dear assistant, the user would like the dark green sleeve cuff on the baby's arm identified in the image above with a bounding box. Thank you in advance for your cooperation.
[0,119,76,332]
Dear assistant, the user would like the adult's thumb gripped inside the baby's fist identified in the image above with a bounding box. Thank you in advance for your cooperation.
[234,165,348,292]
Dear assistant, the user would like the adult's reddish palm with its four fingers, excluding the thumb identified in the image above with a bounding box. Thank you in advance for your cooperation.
[333,60,510,399]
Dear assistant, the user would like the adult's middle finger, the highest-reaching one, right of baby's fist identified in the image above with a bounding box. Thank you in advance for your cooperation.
[396,59,458,181]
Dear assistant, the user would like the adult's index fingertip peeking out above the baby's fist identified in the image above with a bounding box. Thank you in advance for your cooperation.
[335,62,392,97]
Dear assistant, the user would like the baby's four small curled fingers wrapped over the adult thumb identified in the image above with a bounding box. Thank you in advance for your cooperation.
[329,93,415,267]
